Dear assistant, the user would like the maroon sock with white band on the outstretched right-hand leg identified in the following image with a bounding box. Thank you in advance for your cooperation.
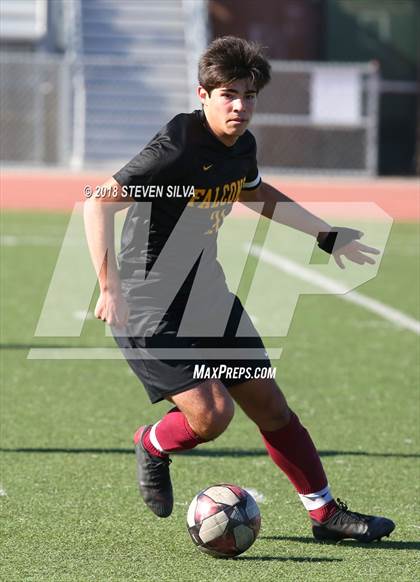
[261,411,336,521]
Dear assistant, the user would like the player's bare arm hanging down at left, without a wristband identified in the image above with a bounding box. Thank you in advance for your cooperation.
[84,178,132,328]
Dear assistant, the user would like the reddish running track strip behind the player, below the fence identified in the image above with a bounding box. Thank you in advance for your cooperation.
[1,170,420,221]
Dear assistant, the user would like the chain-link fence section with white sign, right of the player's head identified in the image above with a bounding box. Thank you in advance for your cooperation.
[252,61,379,175]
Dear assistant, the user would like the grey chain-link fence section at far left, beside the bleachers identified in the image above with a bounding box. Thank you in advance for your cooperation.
[0,53,73,165]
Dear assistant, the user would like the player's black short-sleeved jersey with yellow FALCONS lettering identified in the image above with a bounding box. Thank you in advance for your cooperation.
[114,110,261,322]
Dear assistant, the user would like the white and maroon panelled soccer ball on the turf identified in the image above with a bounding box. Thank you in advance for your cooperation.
[187,483,261,558]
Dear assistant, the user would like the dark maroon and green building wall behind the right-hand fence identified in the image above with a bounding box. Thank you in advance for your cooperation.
[209,0,420,174]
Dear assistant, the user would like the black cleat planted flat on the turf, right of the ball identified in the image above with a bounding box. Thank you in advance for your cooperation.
[311,498,395,543]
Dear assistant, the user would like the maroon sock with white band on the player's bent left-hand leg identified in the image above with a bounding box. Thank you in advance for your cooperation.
[134,407,204,457]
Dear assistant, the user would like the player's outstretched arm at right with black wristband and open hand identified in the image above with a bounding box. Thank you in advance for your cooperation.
[239,182,380,269]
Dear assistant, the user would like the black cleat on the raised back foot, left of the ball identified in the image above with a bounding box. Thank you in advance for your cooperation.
[134,425,174,517]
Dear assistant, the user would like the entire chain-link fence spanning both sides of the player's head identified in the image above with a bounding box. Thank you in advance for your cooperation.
[0,53,378,175]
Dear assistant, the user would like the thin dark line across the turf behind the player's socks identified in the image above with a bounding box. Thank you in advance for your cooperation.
[0,447,420,459]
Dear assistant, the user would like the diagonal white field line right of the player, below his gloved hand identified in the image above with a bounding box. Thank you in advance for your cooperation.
[246,245,420,335]
